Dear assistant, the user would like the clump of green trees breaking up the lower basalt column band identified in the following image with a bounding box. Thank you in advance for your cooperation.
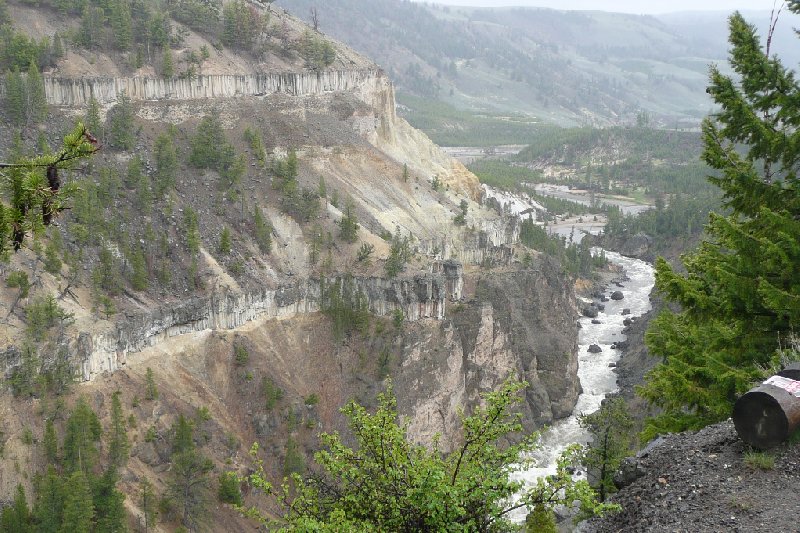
[320,276,370,340]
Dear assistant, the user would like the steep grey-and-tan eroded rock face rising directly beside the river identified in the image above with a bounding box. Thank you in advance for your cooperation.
[394,261,580,449]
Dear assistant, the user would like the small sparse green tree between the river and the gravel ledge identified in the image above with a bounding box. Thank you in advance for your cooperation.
[578,396,633,502]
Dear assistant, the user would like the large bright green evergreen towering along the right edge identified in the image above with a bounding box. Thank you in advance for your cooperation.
[640,4,800,437]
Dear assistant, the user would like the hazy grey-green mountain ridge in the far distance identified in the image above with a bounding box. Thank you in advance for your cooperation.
[277,0,800,127]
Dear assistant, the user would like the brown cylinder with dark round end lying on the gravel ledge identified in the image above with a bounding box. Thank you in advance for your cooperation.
[733,363,800,450]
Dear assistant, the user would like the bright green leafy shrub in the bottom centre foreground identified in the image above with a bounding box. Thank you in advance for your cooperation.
[238,380,609,531]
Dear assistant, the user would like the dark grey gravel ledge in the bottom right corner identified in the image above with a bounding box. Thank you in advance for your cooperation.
[580,421,800,533]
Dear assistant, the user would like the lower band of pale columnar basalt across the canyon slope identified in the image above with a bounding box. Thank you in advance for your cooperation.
[72,270,463,381]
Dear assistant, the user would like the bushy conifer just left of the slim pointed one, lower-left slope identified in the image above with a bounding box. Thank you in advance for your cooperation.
[63,396,103,474]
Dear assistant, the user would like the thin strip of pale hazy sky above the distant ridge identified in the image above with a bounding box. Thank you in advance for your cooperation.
[417,0,781,14]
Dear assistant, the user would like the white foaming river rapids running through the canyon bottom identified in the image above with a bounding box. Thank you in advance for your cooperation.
[511,252,655,522]
